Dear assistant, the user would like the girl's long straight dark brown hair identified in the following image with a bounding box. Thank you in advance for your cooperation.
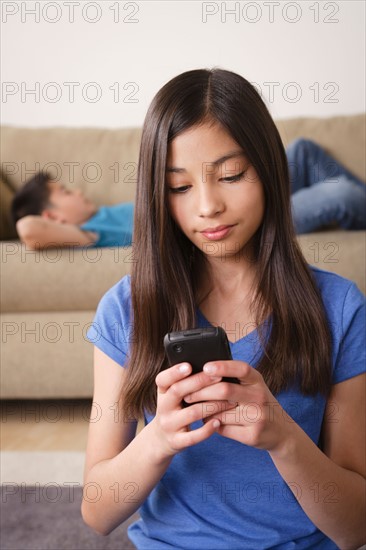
[123,68,331,417]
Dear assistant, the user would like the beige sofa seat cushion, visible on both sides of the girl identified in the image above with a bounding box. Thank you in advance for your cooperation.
[0,230,366,313]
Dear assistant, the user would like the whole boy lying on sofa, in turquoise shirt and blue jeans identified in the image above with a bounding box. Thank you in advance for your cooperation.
[12,139,366,249]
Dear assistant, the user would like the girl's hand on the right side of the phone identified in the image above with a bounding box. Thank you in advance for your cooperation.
[185,361,294,451]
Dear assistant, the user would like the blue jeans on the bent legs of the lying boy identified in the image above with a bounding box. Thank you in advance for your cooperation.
[286,139,366,233]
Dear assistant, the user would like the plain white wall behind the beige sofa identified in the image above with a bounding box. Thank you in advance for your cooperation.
[1,0,365,127]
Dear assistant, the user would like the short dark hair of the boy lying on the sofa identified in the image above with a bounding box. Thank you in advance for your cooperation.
[11,172,51,225]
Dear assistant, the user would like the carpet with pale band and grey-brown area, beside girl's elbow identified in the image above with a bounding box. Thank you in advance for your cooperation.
[0,451,138,550]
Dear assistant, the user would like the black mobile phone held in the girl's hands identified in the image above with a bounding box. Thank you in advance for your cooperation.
[164,327,239,384]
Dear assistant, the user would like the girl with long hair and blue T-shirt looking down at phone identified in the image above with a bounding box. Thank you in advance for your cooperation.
[82,69,365,550]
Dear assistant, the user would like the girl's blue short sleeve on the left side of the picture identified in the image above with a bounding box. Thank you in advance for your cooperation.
[86,275,132,366]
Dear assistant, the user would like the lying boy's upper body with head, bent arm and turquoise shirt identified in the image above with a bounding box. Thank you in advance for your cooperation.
[11,172,133,249]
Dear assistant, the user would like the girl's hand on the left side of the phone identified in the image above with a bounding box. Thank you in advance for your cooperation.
[151,363,236,459]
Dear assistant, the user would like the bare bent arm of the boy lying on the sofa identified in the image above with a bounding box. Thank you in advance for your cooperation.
[16,216,98,250]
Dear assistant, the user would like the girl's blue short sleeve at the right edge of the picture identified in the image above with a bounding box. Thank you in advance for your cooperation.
[333,283,366,384]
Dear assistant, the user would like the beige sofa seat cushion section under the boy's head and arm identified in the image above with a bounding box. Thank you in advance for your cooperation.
[0,241,134,313]
